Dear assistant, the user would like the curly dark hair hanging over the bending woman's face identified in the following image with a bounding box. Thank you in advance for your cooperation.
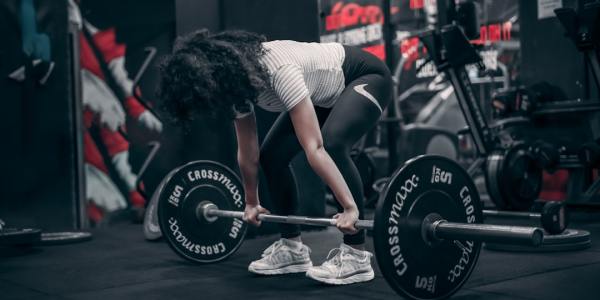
[158,30,269,124]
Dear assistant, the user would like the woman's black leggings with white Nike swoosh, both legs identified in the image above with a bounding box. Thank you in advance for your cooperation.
[260,47,392,245]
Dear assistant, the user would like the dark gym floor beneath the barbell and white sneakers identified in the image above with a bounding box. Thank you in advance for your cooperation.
[0,215,600,300]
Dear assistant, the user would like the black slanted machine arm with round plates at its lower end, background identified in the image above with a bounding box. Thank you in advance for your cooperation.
[420,25,542,210]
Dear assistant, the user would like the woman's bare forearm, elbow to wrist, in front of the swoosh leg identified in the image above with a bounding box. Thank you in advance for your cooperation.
[306,146,356,209]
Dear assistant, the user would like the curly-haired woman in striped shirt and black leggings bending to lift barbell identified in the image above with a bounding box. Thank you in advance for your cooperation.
[159,31,392,284]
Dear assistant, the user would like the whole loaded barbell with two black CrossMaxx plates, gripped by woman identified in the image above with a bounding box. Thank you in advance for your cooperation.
[158,155,544,299]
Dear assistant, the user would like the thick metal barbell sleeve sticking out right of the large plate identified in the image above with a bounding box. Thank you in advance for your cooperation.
[424,220,544,246]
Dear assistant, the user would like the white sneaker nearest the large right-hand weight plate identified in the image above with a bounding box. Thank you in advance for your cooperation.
[306,244,375,285]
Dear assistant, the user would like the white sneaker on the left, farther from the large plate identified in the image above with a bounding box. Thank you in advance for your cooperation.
[248,239,312,275]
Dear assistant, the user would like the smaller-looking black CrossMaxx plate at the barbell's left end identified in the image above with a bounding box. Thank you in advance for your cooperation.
[158,161,247,263]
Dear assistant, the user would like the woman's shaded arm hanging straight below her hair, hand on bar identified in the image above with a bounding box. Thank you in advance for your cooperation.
[235,113,268,225]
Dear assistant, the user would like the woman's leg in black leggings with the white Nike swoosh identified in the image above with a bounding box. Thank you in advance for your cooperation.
[321,69,392,245]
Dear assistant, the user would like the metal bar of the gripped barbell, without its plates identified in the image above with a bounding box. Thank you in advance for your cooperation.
[196,201,544,247]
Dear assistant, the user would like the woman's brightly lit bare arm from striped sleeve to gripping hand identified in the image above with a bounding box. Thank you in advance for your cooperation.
[290,97,358,232]
